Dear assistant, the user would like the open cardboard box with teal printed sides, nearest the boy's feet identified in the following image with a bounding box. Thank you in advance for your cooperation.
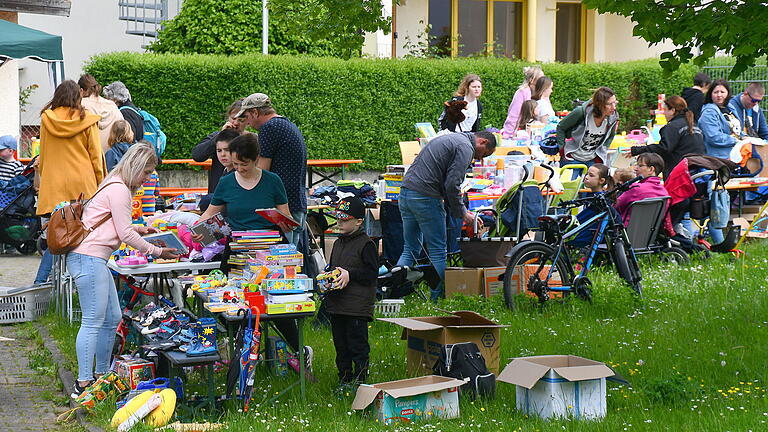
[352,375,464,424]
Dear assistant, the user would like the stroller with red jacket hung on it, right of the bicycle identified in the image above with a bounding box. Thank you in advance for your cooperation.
[665,155,740,253]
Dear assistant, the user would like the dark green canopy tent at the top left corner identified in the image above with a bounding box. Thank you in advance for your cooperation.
[0,20,64,89]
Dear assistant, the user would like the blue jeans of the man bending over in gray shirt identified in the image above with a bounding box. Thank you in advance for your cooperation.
[397,188,446,301]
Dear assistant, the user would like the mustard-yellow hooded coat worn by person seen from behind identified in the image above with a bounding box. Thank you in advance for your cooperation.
[37,107,107,215]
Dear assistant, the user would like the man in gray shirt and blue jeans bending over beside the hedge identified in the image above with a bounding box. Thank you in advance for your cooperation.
[397,132,496,301]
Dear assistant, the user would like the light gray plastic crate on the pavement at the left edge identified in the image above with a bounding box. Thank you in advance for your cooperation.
[0,284,52,324]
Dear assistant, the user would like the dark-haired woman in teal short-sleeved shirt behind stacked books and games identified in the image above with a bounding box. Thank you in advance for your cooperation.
[200,133,291,232]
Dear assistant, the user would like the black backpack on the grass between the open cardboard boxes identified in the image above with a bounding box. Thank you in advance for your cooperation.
[432,342,496,400]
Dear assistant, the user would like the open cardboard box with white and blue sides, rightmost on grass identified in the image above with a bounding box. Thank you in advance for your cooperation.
[497,355,626,420]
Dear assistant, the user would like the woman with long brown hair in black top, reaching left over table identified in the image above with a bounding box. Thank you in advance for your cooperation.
[624,96,707,179]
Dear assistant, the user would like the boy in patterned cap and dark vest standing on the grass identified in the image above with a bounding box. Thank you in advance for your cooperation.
[325,197,379,391]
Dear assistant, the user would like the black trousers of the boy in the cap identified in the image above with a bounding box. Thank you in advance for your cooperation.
[330,314,371,384]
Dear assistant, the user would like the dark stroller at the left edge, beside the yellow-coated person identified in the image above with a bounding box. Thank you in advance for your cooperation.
[0,157,41,255]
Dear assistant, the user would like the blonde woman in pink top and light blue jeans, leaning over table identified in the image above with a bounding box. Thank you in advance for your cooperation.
[67,143,177,395]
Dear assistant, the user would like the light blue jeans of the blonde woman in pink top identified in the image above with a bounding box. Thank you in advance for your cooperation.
[67,252,122,381]
